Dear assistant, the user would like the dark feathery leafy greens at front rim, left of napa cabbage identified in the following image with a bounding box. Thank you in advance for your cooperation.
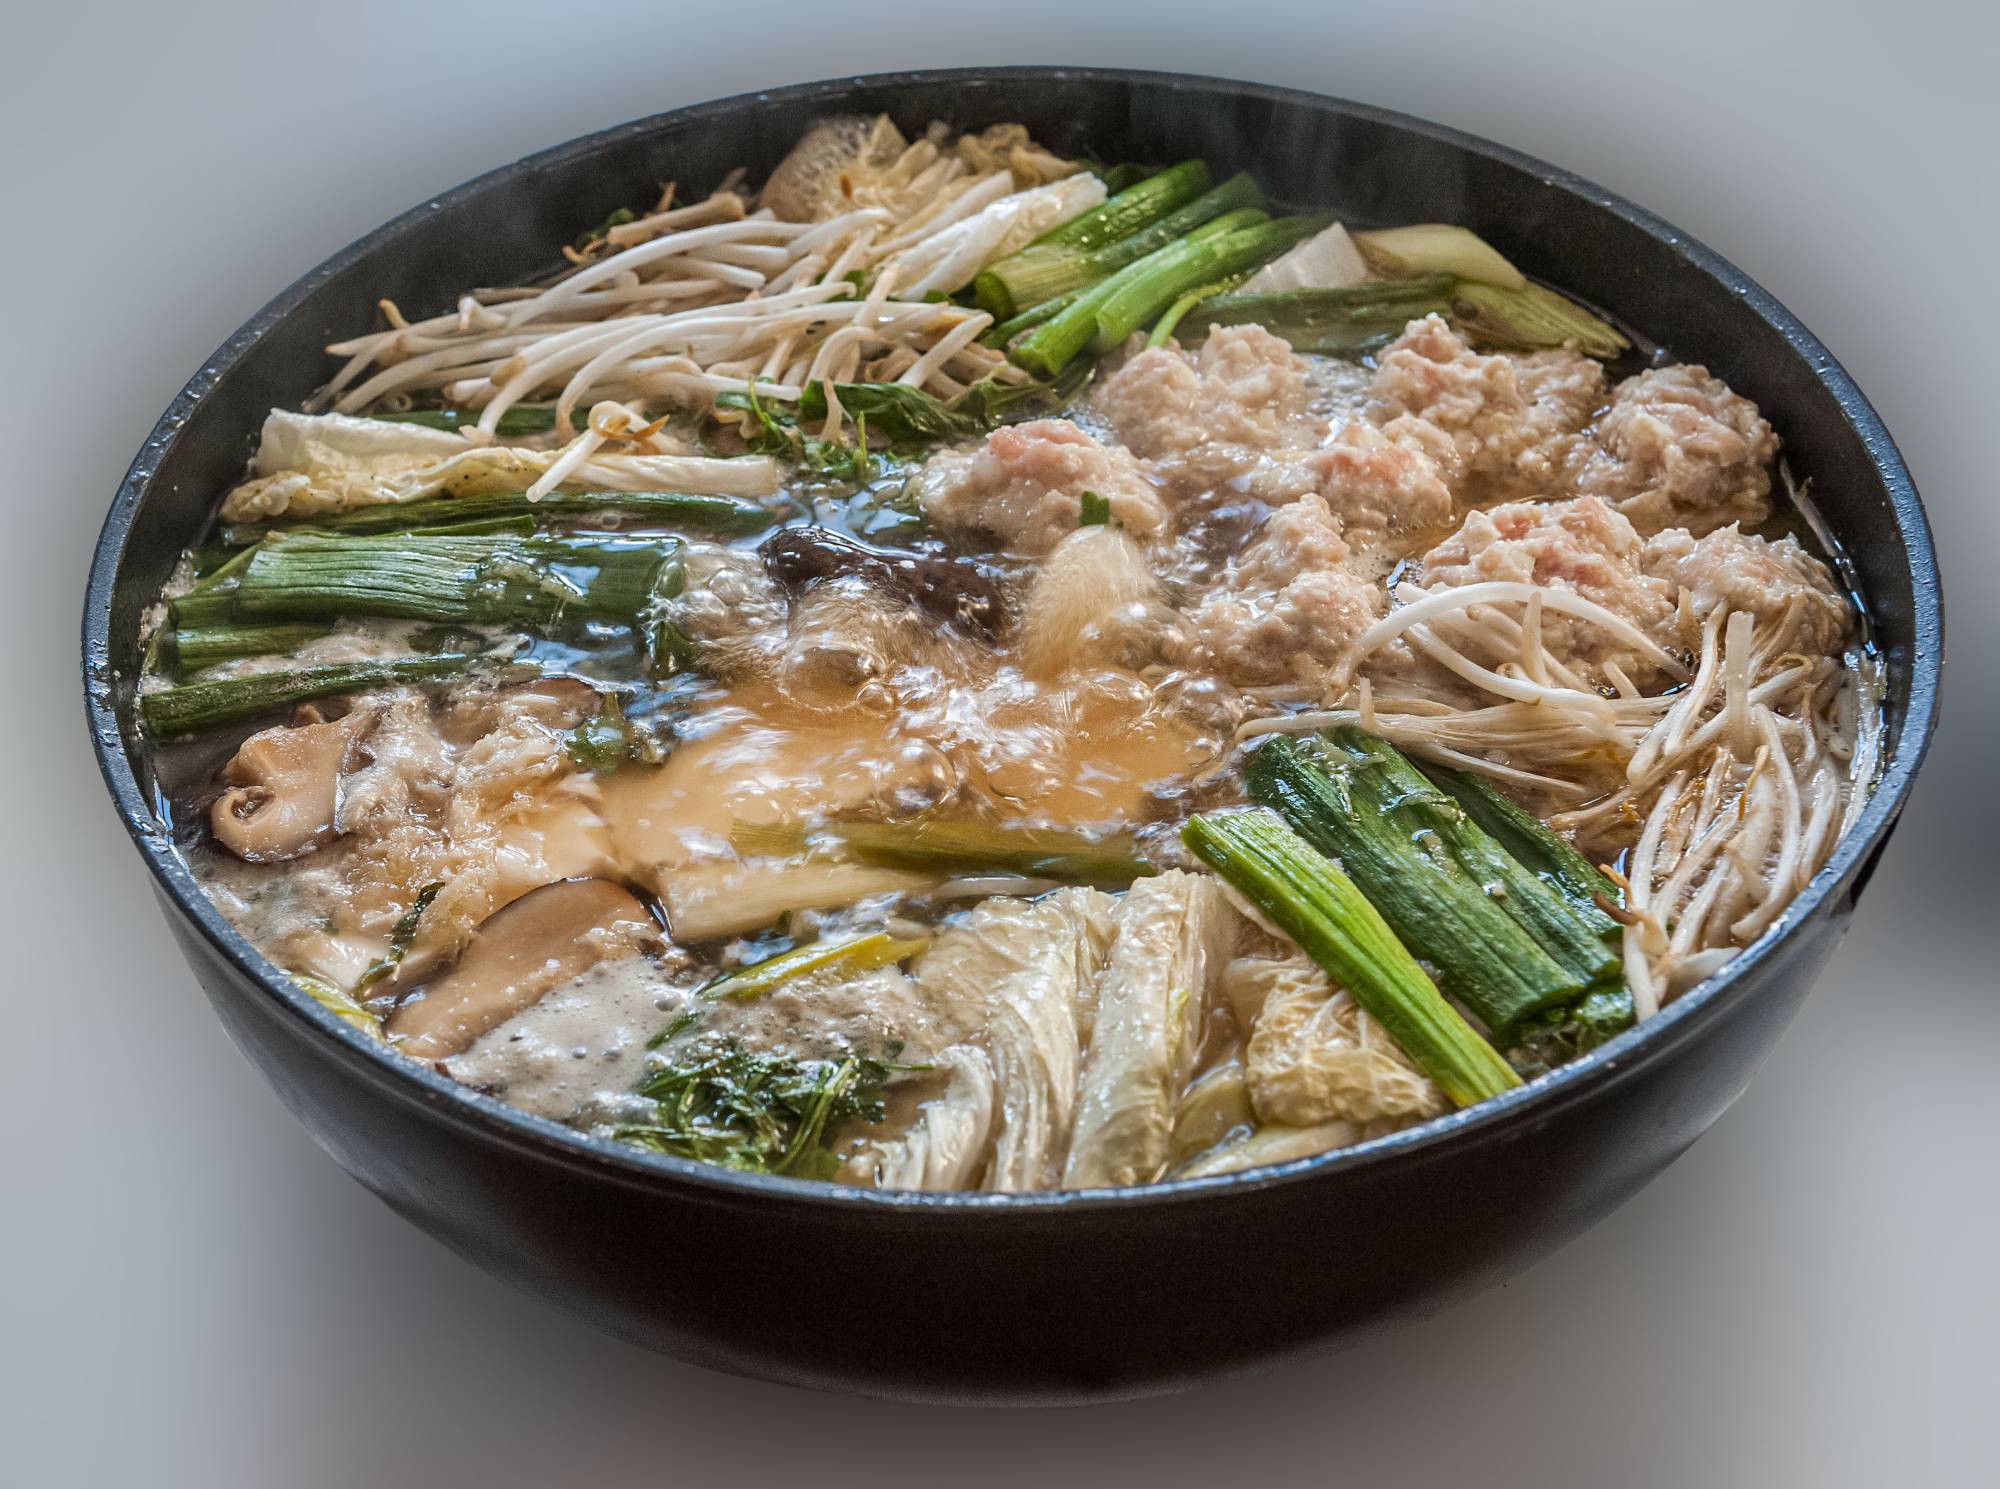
[616,1041,910,1179]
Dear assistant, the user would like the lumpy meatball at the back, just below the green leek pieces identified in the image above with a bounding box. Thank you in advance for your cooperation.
[1368,316,1604,502]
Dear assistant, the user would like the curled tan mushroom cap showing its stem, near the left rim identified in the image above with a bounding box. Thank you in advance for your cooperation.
[208,708,374,863]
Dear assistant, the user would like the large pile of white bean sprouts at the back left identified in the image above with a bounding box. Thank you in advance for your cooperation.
[316,140,1104,442]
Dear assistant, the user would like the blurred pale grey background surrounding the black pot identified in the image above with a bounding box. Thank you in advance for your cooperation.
[0,0,2000,1489]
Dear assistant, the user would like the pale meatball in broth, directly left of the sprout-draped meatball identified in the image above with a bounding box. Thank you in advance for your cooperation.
[1186,494,1382,686]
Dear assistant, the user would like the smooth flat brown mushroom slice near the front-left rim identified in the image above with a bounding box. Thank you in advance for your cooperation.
[386,879,656,1061]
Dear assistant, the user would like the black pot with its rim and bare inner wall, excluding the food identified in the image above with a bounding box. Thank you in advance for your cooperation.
[84,68,1942,1401]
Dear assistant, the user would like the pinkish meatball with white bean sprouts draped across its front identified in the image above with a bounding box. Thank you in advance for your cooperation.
[1422,496,1676,682]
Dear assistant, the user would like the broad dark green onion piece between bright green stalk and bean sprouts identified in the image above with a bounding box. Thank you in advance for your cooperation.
[1246,730,1618,1035]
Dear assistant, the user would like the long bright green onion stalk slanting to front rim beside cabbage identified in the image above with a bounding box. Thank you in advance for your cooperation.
[1180,811,1520,1107]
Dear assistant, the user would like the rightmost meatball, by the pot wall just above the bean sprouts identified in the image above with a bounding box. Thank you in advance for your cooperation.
[1642,522,1854,656]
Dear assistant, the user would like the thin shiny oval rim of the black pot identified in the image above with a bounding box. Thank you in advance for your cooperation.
[82,66,1944,1217]
